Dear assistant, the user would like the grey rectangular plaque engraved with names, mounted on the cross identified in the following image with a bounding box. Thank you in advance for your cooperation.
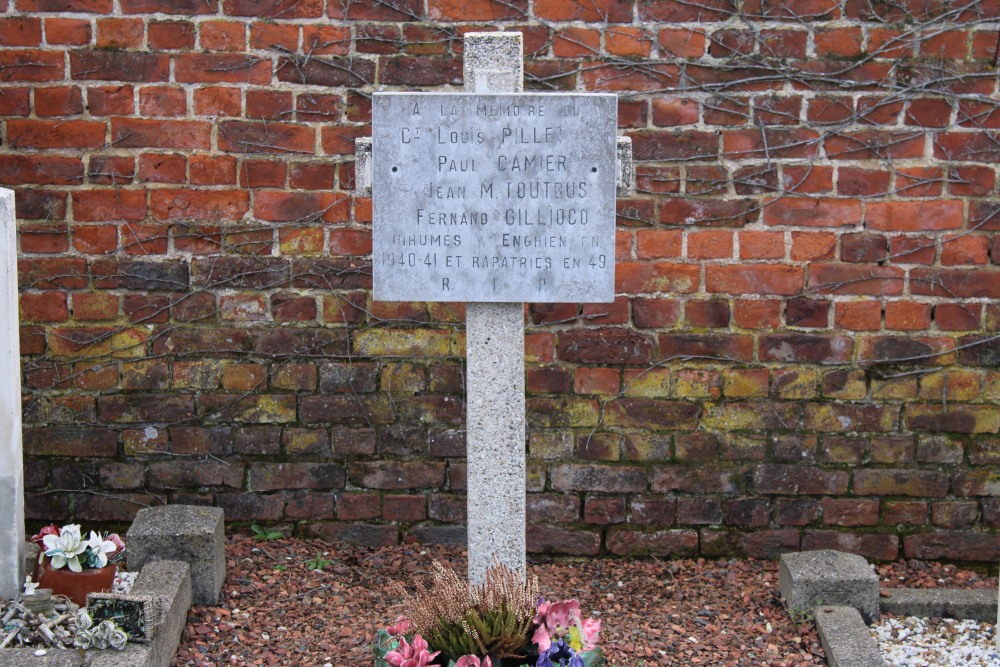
[372,93,618,303]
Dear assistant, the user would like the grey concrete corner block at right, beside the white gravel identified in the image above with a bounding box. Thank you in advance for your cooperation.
[778,549,879,623]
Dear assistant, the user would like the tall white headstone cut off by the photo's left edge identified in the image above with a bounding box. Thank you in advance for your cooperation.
[0,188,24,600]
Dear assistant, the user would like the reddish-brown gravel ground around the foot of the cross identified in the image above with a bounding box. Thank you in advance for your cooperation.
[172,535,996,667]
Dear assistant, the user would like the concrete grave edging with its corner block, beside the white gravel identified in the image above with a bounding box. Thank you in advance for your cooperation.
[779,550,997,667]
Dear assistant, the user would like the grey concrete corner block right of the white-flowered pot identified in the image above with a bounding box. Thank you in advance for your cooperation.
[125,505,226,604]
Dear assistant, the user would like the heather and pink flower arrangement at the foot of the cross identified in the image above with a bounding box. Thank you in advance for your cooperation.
[372,563,604,667]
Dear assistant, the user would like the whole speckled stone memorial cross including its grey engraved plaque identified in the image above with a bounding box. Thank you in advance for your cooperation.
[355,32,632,583]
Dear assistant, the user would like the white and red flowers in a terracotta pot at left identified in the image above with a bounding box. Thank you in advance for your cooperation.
[31,523,125,607]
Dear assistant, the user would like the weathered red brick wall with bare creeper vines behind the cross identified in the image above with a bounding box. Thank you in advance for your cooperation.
[0,0,1000,562]
